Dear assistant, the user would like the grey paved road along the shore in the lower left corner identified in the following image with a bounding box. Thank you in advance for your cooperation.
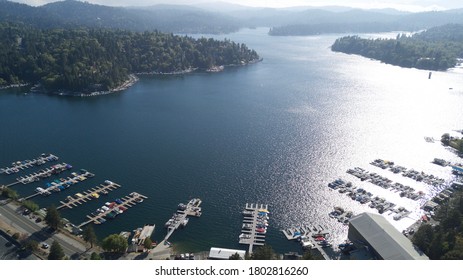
[0,201,86,256]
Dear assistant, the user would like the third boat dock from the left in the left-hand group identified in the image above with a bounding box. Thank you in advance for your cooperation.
[22,169,95,200]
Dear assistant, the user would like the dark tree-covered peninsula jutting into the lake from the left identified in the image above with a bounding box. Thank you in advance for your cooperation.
[0,23,259,93]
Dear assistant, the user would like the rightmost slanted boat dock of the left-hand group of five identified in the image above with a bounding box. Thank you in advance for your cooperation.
[77,192,148,228]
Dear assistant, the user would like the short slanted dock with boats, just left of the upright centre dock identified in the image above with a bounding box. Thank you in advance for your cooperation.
[163,198,202,242]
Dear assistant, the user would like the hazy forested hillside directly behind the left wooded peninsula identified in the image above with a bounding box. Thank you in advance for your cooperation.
[0,0,240,34]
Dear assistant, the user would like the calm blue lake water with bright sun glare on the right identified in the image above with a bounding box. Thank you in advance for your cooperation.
[0,29,463,252]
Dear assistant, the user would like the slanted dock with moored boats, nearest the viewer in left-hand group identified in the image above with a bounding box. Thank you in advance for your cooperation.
[77,192,148,228]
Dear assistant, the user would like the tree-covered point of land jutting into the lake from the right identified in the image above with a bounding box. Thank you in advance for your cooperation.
[331,24,463,70]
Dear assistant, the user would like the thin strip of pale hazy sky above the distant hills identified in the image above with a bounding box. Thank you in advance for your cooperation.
[13,0,463,11]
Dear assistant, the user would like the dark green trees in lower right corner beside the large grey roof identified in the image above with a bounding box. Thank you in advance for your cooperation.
[412,187,463,260]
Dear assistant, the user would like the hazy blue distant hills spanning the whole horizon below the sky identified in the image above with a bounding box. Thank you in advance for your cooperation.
[0,0,463,36]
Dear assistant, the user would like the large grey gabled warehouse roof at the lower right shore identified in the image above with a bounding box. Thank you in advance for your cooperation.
[349,213,428,260]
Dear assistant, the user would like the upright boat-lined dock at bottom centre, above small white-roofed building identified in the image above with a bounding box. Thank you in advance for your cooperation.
[239,203,269,254]
